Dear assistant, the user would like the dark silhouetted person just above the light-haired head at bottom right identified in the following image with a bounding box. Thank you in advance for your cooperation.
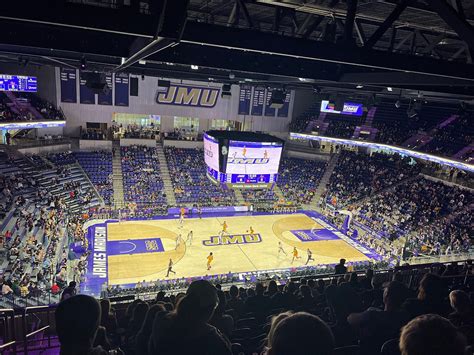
[403,274,450,318]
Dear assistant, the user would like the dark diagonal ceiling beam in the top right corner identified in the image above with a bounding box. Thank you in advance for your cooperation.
[430,0,474,55]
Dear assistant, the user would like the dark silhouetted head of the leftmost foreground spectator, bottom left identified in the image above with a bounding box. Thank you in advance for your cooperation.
[55,295,107,355]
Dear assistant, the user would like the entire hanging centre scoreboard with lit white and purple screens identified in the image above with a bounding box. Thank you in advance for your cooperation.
[204,131,284,188]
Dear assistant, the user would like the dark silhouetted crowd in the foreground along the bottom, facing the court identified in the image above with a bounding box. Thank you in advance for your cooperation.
[56,260,474,355]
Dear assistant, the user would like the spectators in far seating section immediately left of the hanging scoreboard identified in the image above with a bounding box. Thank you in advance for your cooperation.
[165,147,235,206]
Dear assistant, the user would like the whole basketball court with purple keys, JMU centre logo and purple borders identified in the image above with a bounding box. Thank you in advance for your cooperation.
[81,211,377,294]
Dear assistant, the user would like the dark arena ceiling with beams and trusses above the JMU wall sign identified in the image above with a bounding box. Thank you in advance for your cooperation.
[0,0,474,100]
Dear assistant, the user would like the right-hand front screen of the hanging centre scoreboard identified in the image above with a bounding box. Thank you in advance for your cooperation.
[225,140,283,184]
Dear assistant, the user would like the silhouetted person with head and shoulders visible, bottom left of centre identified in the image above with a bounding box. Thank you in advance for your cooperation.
[149,280,231,355]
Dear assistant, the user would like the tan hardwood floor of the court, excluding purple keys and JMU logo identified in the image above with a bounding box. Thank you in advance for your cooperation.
[107,213,369,285]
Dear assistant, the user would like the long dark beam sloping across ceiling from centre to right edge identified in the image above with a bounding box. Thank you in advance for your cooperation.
[177,23,474,78]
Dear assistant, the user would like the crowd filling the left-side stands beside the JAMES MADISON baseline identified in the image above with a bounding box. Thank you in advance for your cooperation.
[0,155,87,307]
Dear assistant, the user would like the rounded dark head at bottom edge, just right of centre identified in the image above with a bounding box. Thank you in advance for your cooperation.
[266,312,335,355]
